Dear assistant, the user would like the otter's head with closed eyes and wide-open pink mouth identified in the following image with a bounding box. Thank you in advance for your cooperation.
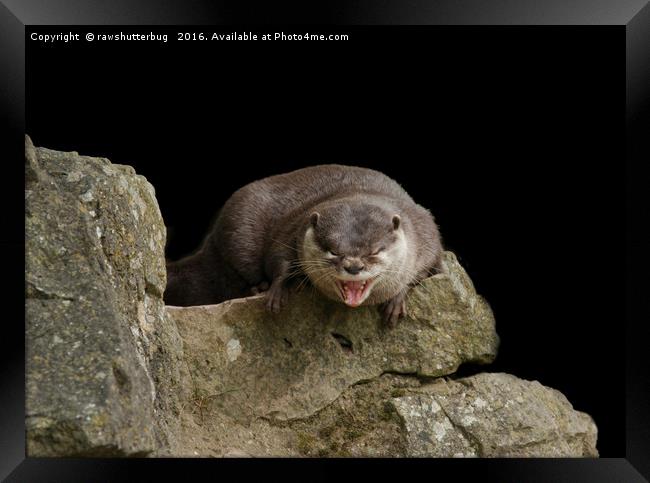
[300,202,408,307]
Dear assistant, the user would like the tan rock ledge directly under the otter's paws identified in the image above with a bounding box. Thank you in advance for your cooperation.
[167,253,498,426]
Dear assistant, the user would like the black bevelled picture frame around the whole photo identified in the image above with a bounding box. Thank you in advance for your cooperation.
[0,0,650,482]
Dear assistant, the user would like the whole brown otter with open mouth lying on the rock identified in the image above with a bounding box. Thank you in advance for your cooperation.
[165,165,443,326]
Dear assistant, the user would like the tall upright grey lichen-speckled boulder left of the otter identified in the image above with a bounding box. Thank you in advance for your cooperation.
[25,138,181,456]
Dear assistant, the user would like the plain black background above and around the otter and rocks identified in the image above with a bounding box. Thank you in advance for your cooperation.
[26,27,625,457]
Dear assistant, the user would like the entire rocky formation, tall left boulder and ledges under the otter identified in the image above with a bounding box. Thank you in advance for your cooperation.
[25,138,598,457]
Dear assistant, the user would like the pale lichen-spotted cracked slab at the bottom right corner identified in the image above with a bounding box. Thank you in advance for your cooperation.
[392,374,598,457]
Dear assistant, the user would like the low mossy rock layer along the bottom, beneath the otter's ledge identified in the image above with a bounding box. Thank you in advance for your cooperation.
[159,374,598,458]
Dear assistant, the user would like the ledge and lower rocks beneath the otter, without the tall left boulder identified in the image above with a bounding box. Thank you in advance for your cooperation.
[161,284,598,457]
